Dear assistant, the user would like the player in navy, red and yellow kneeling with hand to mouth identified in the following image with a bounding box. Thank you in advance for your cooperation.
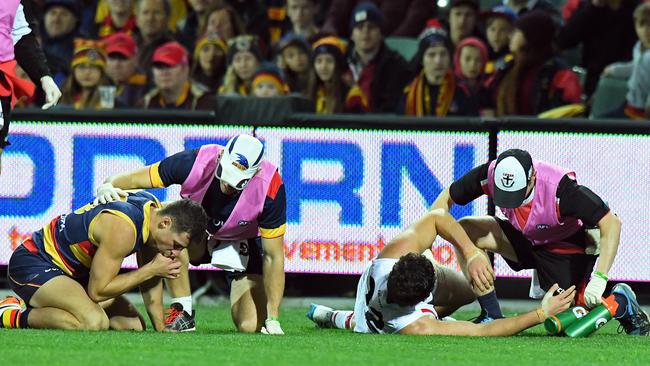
[0,191,207,331]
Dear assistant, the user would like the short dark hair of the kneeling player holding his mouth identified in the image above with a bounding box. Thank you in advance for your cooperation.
[158,199,208,245]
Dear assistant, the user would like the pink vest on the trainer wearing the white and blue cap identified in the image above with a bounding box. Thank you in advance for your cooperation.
[181,145,277,240]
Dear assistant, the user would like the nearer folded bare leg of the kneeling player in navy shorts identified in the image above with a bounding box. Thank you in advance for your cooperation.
[27,276,109,330]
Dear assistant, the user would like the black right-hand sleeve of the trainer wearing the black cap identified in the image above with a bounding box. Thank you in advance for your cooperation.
[557,175,609,226]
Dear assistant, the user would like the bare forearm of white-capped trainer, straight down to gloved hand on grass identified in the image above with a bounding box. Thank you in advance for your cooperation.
[262,235,284,318]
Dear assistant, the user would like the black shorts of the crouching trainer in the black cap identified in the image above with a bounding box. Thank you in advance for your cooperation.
[495,217,598,292]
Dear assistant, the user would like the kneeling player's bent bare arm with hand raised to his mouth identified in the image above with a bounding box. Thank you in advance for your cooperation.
[88,213,180,302]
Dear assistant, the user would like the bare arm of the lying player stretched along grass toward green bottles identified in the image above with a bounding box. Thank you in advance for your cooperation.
[400,284,575,336]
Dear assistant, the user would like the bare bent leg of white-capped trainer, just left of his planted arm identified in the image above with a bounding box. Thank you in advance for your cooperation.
[230,273,266,333]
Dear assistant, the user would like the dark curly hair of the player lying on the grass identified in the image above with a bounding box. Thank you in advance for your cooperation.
[387,253,436,306]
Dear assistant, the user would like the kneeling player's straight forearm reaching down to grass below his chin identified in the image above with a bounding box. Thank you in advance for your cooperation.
[136,246,165,332]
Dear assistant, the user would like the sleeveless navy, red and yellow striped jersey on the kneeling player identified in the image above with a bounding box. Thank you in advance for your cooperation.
[23,191,161,278]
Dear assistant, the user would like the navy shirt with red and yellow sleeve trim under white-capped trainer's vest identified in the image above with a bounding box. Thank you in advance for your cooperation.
[149,149,287,238]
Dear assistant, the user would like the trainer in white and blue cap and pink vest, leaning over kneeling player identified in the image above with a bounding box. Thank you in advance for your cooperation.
[91,134,286,334]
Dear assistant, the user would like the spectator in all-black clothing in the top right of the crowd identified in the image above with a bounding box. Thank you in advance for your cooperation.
[556,0,643,96]
